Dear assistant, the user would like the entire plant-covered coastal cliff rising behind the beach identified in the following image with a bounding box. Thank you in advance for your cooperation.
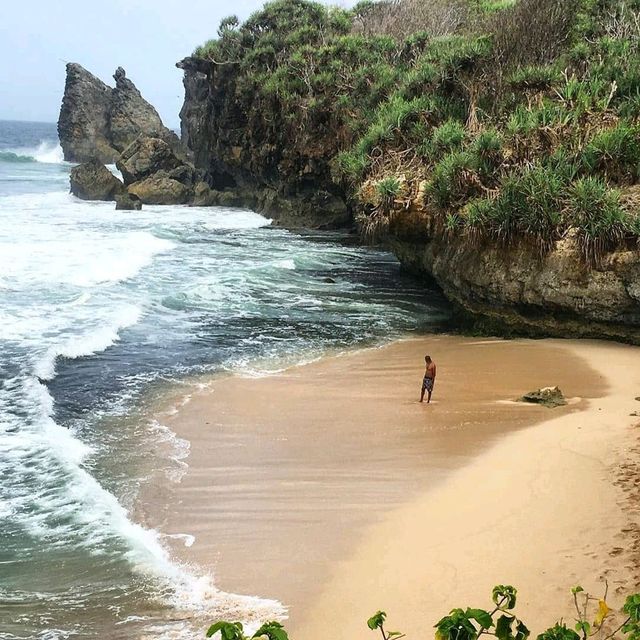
[178,0,640,342]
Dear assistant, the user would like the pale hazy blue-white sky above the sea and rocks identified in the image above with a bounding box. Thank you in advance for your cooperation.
[0,0,354,127]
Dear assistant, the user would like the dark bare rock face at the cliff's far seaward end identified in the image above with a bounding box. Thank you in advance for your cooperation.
[177,57,352,229]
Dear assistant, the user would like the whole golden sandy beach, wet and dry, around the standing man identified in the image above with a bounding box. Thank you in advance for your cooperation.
[143,336,640,640]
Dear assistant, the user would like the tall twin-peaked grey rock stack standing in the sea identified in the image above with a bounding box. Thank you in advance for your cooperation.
[58,63,185,164]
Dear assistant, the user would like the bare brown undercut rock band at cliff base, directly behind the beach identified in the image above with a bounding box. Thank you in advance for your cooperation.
[389,211,640,343]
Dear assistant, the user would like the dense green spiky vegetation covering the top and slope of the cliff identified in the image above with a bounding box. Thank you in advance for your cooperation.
[194,0,640,264]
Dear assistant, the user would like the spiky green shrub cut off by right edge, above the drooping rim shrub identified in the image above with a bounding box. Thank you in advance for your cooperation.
[582,122,640,183]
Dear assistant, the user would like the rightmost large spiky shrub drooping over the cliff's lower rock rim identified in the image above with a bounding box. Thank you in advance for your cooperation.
[564,176,630,266]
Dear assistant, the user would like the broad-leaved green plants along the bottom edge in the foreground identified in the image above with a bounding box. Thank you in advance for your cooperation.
[207,585,640,640]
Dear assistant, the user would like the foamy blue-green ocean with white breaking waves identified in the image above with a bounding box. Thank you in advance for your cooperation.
[0,121,448,640]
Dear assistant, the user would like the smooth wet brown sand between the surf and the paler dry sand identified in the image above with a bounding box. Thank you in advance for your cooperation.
[134,335,640,639]
